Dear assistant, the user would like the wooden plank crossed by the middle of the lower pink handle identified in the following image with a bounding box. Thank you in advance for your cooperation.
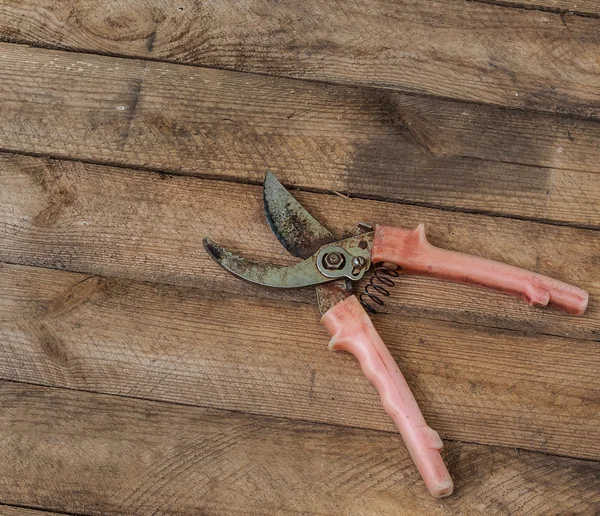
[0,265,600,459]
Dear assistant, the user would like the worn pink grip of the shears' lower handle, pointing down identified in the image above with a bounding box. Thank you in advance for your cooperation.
[321,296,453,498]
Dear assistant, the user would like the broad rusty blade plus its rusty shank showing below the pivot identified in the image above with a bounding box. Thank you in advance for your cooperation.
[263,171,352,314]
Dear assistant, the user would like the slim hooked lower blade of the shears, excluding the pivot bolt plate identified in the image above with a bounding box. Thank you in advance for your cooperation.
[202,238,331,288]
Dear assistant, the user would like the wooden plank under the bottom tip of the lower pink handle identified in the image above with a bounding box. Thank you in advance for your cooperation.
[0,383,600,516]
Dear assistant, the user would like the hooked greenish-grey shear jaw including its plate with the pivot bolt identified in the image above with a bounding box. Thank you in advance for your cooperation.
[202,233,373,288]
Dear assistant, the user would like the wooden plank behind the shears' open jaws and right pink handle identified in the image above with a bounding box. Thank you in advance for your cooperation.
[0,155,600,340]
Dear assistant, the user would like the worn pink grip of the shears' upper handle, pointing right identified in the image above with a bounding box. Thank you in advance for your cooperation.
[371,224,588,315]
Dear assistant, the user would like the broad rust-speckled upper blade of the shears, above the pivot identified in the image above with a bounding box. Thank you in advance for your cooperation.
[263,171,337,258]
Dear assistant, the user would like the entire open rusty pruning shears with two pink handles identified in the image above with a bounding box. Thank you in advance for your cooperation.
[203,172,588,498]
